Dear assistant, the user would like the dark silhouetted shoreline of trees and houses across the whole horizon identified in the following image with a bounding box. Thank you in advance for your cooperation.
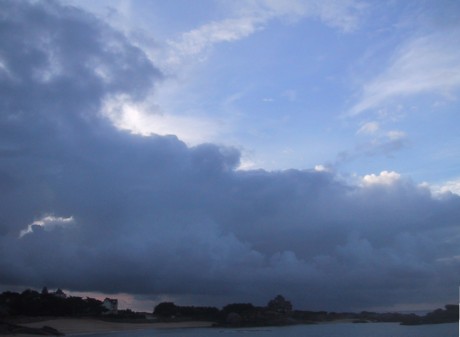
[0,287,459,327]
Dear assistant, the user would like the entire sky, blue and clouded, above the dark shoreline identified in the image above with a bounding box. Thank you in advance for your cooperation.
[0,0,460,311]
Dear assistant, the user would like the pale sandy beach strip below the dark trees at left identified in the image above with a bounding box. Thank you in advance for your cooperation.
[2,318,213,337]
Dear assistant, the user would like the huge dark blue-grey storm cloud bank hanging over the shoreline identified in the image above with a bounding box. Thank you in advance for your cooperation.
[0,1,460,309]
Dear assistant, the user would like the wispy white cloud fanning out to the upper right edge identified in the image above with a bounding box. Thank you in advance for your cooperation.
[349,30,460,115]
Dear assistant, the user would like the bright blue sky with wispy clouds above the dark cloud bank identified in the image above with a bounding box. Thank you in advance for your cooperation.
[71,1,460,186]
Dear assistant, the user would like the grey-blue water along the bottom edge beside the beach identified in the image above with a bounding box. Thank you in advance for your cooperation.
[81,323,459,337]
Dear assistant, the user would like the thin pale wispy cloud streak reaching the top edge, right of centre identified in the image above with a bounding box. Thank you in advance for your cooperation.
[165,0,365,68]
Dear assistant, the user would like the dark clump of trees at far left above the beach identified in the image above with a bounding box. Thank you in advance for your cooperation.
[0,288,107,316]
